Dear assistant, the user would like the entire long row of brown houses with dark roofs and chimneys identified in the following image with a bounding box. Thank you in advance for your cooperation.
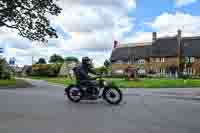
[111,30,200,76]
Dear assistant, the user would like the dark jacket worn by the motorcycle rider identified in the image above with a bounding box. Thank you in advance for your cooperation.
[74,64,97,83]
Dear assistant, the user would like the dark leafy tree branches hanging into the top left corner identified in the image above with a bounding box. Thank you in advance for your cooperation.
[0,0,62,41]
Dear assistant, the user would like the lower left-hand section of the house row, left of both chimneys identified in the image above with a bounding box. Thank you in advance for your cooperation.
[110,42,151,74]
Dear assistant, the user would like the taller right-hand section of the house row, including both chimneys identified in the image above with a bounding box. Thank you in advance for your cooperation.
[149,30,200,75]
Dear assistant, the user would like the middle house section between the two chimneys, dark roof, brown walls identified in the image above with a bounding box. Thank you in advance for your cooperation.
[149,33,179,75]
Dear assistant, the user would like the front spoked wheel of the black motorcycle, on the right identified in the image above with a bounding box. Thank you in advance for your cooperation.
[103,87,122,105]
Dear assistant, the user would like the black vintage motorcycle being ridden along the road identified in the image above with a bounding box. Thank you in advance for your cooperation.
[65,76,122,105]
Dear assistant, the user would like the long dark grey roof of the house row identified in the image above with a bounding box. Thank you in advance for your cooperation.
[111,36,200,61]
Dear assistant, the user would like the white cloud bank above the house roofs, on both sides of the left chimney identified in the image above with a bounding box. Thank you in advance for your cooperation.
[123,12,200,43]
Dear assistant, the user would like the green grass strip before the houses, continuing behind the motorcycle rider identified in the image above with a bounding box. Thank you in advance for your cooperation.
[31,77,200,88]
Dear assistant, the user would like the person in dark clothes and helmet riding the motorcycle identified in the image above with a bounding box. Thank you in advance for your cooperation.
[74,57,98,96]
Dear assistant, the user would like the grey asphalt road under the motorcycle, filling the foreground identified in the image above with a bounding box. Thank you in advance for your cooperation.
[0,81,200,133]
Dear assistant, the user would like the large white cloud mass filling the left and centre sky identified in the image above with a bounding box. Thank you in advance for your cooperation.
[0,0,136,66]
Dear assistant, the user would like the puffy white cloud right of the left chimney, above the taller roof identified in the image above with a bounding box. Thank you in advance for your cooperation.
[149,12,200,35]
